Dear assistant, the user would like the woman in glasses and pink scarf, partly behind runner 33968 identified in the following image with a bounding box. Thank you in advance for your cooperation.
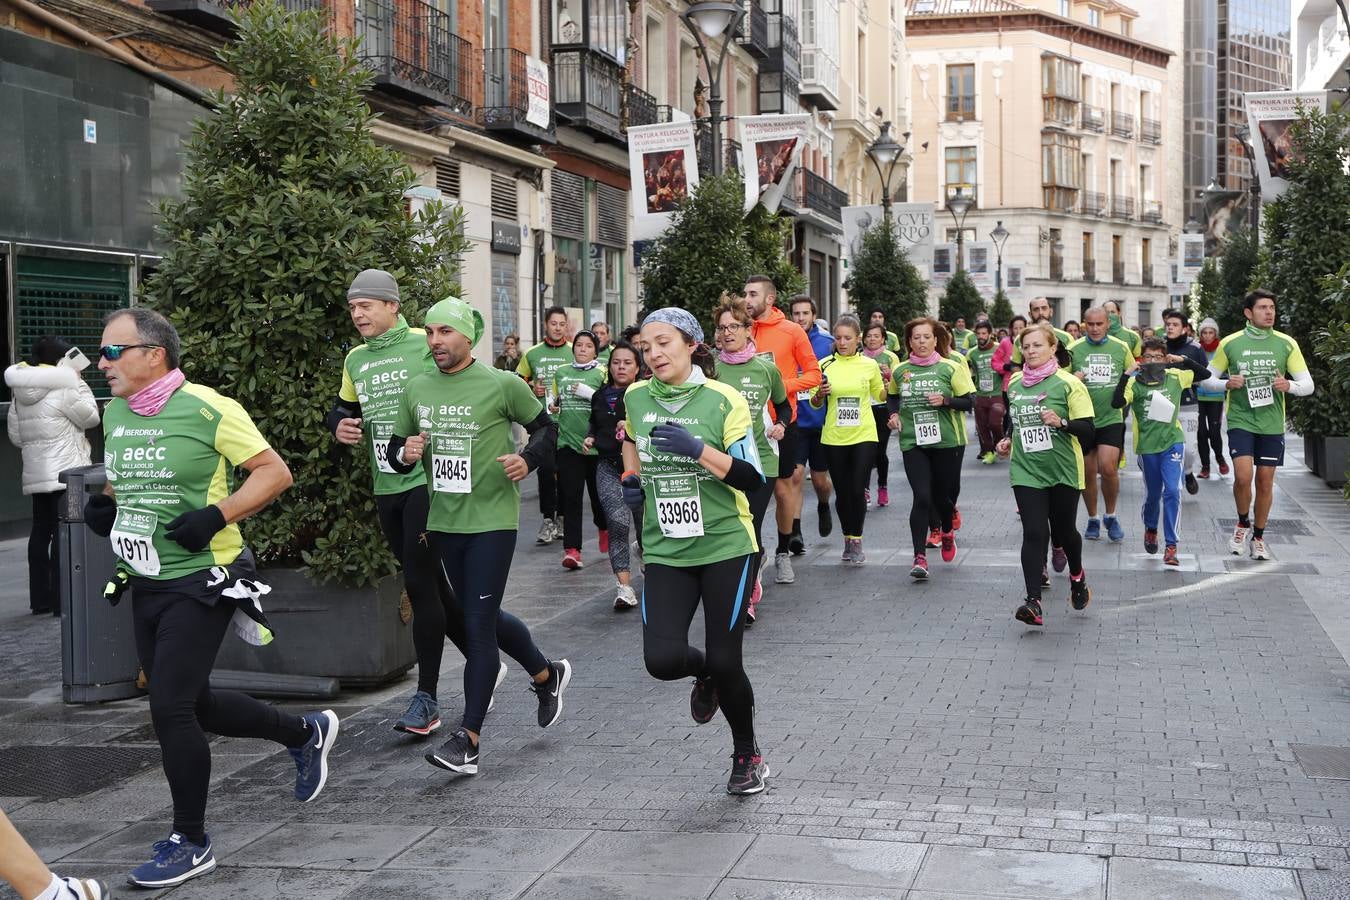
[713,294,792,625]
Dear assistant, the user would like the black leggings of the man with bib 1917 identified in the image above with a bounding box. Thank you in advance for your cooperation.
[131,588,309,843]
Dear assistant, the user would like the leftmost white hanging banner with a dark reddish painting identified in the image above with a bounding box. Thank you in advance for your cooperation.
[628,121,698,240]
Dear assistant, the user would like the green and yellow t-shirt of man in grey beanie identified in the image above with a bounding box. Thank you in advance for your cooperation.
[338,328,436,495]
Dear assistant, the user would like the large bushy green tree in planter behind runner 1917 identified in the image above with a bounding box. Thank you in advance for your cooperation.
[146,0,467,584]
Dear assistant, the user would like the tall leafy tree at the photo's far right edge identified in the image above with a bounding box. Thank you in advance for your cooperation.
[1258,109,1350,436]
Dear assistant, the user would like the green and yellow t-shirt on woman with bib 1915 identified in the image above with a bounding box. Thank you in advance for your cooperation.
[1008,368,1092,491]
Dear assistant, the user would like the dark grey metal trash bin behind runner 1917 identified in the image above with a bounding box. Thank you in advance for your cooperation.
[59,466,140,703]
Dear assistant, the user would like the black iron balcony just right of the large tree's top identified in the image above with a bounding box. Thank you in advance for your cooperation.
[356,0,482,116]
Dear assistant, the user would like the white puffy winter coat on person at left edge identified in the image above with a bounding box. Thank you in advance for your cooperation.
[4,363,99,494]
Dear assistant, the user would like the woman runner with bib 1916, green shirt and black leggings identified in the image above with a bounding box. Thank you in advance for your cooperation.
[887,317,975,580]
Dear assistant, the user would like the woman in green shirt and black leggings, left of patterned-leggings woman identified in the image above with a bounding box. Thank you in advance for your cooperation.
[548,331,609,569]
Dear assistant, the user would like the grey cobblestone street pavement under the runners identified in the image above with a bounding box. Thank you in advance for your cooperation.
[0,441,1350,900]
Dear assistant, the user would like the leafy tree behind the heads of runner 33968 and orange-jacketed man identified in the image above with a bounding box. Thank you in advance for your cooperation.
[640,171,799,328]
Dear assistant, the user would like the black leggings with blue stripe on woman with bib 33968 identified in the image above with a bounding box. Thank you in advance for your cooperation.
[643,553,757,754]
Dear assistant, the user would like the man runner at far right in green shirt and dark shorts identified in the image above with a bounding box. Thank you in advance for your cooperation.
[1204,290,1314,560]
